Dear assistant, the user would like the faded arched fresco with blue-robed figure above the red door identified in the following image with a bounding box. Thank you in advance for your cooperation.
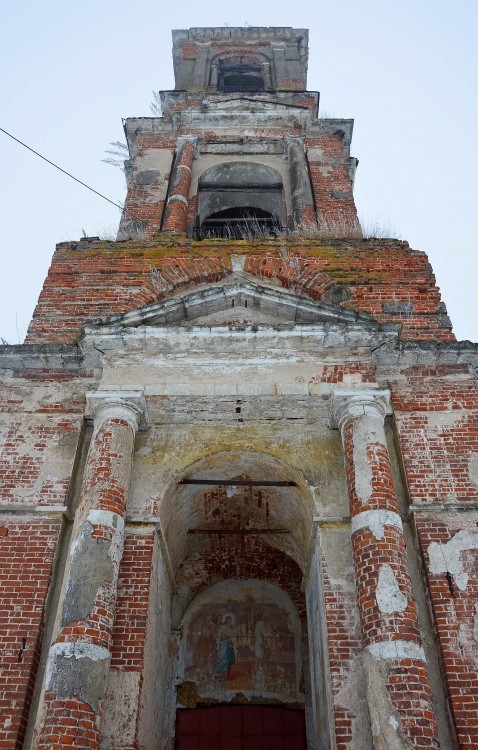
[184,597,297,696]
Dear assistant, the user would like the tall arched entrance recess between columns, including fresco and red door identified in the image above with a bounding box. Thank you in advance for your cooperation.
[157,450,329,750]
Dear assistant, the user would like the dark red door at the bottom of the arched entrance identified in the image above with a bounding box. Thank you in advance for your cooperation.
[175,706,306,750]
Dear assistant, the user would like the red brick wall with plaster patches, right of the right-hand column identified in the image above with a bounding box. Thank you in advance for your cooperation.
[392,365,478,750]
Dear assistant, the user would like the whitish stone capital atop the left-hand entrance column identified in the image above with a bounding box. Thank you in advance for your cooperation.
[85,391,148,432]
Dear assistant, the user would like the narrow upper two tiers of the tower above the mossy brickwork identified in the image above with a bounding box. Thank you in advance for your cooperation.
[119,27,360,240]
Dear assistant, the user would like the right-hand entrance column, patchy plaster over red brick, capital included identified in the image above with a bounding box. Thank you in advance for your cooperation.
[331,390,439,750]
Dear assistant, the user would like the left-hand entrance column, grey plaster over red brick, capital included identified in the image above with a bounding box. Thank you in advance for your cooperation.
[33,391,144,750]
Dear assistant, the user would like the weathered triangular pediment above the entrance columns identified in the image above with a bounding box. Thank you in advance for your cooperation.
[89,282,379,328]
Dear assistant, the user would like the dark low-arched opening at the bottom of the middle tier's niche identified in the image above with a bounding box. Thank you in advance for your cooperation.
[195,206,284,240]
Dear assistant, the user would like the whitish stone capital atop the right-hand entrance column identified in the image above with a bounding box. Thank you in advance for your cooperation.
[329,388,392,431]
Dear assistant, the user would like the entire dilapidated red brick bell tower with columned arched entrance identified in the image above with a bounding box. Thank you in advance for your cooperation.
[0,27,478,750]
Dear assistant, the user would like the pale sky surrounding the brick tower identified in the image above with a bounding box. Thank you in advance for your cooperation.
[0,0,478,343]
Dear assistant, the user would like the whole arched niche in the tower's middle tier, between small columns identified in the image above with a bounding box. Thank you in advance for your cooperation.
[197,161,285,237]
